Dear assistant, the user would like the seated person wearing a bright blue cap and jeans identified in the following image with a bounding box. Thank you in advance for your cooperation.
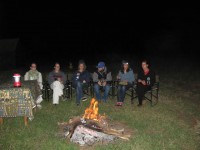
[93,62,112,102]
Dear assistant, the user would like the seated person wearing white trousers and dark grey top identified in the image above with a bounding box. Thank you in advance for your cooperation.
[48,63,66,105]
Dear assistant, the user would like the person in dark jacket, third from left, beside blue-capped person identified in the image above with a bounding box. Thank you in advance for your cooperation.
[72,60,90,106]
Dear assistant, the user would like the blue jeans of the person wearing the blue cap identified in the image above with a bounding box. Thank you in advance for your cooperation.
[94,83,110,102]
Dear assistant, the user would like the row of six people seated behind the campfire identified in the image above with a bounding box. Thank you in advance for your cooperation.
[24,60,155,107]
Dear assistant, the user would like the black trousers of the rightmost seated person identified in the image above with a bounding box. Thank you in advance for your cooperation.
[136,83,151,105]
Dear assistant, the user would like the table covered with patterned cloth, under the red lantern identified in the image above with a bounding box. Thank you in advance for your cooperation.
[0,80,41,125]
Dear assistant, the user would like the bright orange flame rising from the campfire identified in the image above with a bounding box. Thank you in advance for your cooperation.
[83,98,100,121]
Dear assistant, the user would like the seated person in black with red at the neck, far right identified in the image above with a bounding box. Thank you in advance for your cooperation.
[136,60,155,106]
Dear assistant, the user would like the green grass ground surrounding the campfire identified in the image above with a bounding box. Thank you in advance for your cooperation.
[0,65,200,150]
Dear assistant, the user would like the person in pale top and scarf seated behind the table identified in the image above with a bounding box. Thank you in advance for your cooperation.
[24,63,43,108]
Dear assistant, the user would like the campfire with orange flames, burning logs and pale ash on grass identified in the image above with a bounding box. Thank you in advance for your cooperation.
[58,98,131,146]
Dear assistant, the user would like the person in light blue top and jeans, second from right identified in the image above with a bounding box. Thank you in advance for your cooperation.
[116,60,135,106]
